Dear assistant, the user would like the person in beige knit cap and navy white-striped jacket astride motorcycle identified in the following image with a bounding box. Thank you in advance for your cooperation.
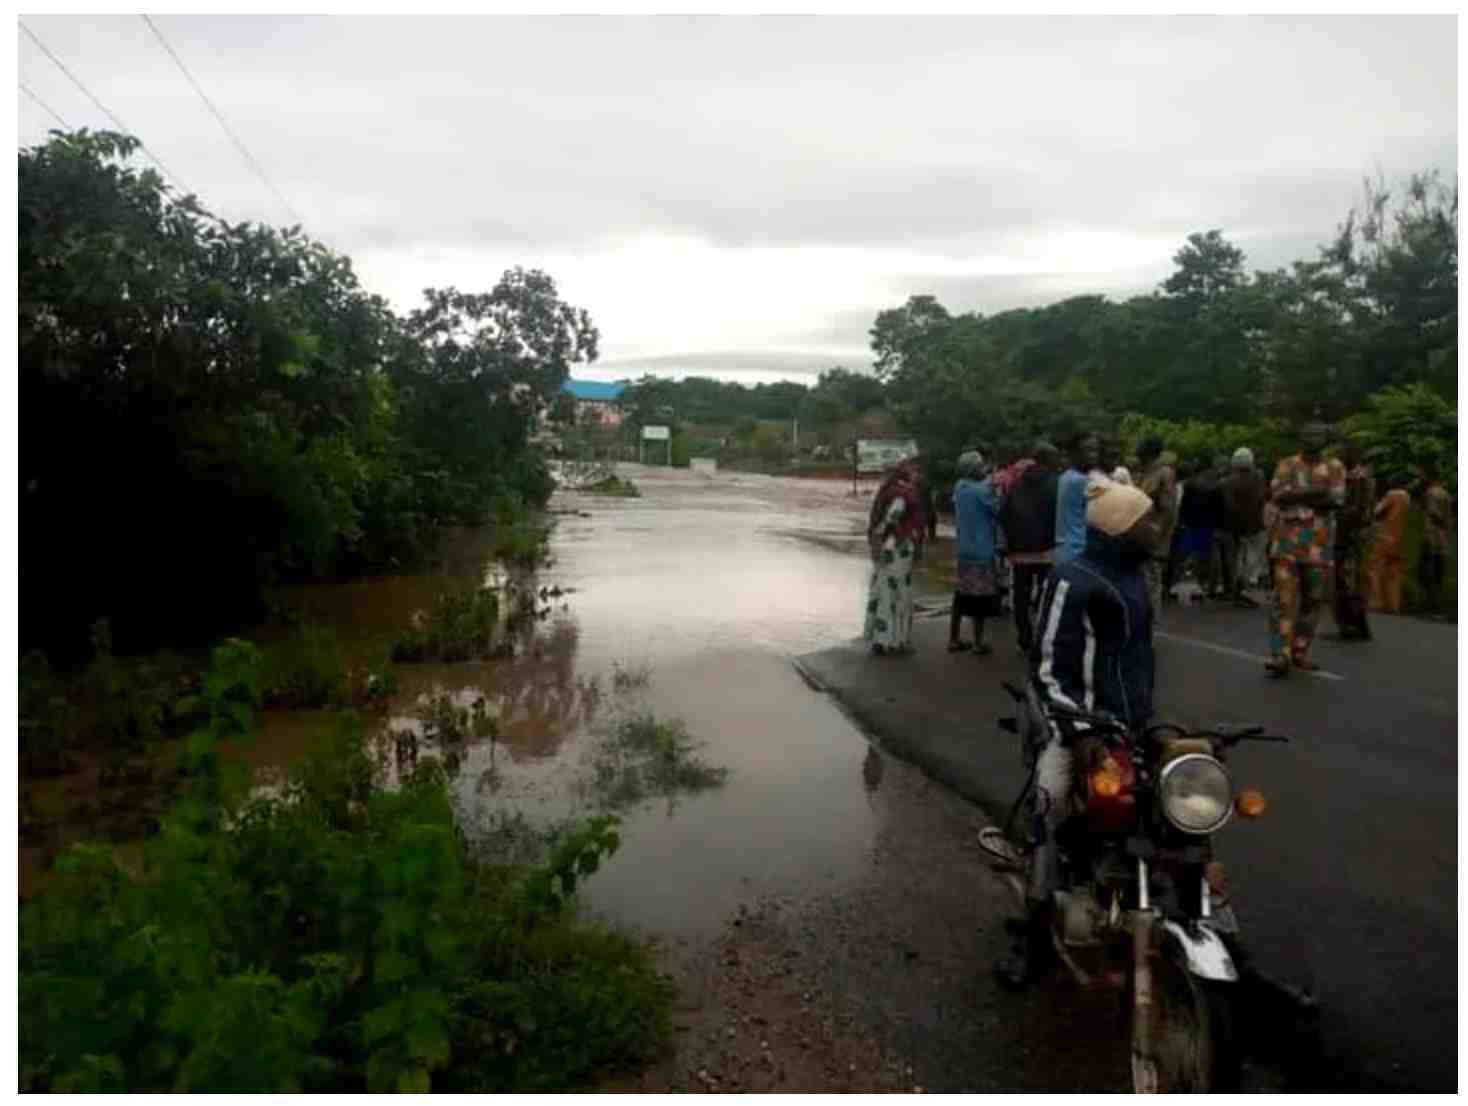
[995,480,1169,987]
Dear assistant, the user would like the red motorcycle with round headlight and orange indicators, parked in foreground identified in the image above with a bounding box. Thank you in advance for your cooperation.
[981,683,1289,1093]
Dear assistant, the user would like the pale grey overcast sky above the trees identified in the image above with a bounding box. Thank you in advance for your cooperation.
[18,15,1458,380]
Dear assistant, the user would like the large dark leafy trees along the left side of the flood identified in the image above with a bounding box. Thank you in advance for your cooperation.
[18,131,597,665]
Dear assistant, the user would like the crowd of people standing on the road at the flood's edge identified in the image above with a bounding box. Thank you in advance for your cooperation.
[865,423,1453,676]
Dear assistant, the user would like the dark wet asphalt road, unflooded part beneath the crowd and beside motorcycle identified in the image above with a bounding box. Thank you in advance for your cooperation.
[800,572,1458,1090]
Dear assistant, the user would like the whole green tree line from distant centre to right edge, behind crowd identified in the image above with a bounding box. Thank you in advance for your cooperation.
[601,173,1458,499]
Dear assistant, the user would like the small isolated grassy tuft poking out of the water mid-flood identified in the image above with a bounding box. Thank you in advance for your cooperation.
[581,711,728,809]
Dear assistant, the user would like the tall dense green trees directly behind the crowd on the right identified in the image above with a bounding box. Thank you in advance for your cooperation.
[872,176,1458,475]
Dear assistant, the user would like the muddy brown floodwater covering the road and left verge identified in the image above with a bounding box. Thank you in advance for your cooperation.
[21,466,944,937]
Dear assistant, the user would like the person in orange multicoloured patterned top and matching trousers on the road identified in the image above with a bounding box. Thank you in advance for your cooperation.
[1264,422,1346,676]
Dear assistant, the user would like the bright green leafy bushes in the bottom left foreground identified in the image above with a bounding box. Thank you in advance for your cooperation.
[19,642,671,1093]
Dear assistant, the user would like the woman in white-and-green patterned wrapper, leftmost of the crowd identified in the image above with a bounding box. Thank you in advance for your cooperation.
[862,457,928,655]
